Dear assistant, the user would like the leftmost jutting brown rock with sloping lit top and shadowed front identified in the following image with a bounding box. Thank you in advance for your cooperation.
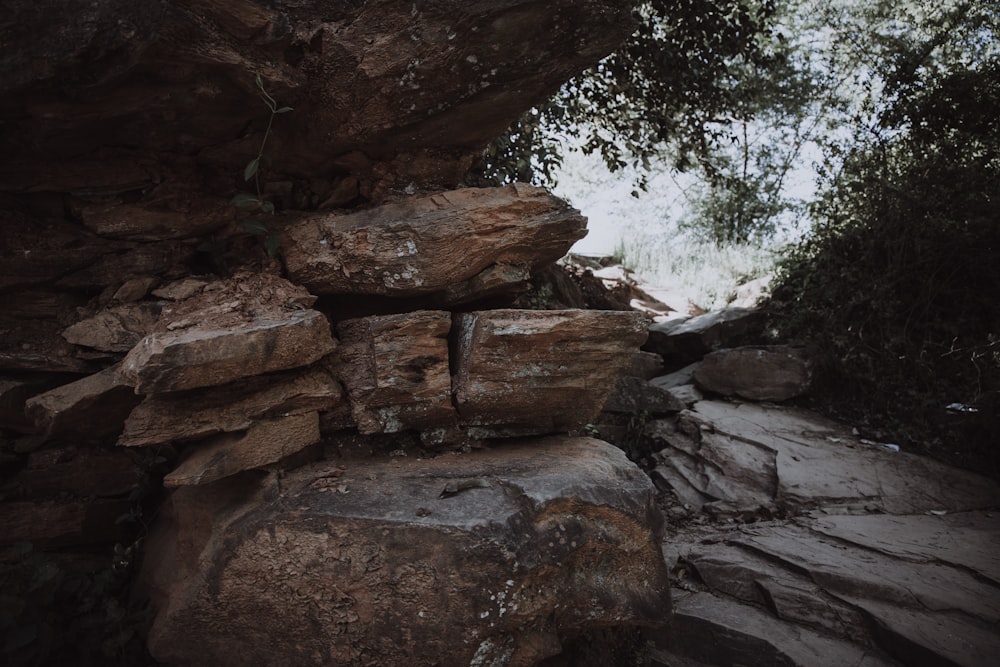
[25,364,140,444]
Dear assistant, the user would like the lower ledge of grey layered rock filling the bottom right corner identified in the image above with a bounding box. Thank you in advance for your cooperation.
[672,512,1000,667]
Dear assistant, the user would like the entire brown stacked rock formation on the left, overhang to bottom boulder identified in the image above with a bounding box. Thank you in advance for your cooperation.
[0,0,669,665]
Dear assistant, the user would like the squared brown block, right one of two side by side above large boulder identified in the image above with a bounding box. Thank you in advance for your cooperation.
[453,310,646,433]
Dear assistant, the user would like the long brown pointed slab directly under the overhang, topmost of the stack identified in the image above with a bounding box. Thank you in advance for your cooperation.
[282,184,587,305]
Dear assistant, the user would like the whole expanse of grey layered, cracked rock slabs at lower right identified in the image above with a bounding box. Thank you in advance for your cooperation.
[653,401,1000,667]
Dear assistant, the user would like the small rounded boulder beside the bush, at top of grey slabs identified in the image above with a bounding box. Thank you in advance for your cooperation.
[694,345,812,401]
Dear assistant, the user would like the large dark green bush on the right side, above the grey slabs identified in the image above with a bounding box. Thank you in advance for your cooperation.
[769,60,1000,475]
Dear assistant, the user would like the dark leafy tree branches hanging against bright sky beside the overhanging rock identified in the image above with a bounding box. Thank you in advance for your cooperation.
[473,0,783,192]
